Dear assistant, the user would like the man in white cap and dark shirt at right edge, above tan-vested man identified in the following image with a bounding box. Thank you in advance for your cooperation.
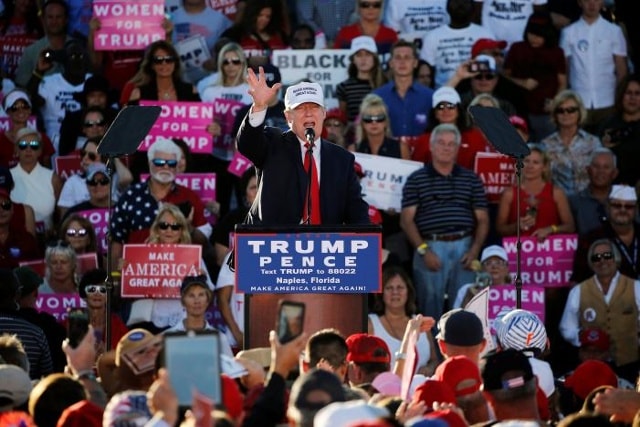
[571,185,640,283]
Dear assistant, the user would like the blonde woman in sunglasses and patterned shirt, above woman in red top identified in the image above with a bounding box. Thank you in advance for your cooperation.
[541,90,602,196]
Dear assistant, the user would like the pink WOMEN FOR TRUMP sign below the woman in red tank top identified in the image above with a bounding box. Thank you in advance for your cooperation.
[502,234,578,287]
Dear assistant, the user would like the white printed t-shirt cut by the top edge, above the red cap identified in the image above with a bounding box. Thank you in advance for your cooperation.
[475,0,547,45]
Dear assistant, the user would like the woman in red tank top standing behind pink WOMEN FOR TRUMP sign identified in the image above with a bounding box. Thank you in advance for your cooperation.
[496,144,575,241]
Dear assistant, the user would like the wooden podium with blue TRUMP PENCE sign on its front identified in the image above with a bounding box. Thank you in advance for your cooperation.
[234,225,382,348]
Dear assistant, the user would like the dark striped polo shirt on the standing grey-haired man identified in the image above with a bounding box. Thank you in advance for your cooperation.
[402,163,488,236]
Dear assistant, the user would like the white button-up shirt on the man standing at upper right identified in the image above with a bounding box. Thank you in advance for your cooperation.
[560,17,627,108]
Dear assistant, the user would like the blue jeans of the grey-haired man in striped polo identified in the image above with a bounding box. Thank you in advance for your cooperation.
[413,236,475,321]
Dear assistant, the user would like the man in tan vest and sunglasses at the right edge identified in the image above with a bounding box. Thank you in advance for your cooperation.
[560,239,640,382]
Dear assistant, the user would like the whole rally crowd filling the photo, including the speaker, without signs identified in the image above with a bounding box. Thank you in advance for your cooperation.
[0,0,640,427]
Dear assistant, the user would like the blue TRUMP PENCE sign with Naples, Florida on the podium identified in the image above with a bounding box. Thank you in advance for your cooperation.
[235,233,382,294]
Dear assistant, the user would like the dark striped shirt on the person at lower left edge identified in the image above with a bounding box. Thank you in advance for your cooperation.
[0,313,53,380]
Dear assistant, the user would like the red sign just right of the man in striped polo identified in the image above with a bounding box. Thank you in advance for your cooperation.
[473,152,515,203]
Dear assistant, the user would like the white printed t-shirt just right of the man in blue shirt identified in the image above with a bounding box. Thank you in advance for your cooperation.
[420,24,494,88]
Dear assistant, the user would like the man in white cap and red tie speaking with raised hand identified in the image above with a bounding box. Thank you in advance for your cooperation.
[237,67,369,225]
